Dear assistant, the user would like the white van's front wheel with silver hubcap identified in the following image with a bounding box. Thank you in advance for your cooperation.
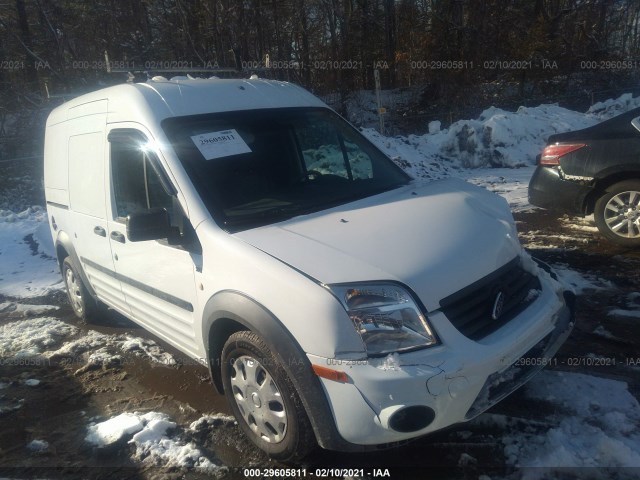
[222,331,315,461]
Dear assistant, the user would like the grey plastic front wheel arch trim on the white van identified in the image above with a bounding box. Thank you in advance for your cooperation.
[202,290,362,451]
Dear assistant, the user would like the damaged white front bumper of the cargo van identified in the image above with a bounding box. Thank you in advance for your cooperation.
[309,277,574,448]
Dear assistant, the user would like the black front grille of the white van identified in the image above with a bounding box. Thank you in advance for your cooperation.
[440,257,541,340]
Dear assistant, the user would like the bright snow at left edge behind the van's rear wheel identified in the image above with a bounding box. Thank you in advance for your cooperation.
[0,205,62,297]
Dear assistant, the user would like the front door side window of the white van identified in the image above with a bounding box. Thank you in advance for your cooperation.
[111,135,173,219]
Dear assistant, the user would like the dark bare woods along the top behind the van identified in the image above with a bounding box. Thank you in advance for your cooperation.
[0,0,640,133]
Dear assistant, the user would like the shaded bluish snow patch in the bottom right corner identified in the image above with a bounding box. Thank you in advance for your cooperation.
[502,371,640,479]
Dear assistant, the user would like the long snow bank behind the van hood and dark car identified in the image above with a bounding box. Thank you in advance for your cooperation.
[362,94,640,171]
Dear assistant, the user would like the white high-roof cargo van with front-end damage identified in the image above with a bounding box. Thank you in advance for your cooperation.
[45,78,572,459]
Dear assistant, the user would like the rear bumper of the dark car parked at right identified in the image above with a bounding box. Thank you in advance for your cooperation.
[529,166,592,215]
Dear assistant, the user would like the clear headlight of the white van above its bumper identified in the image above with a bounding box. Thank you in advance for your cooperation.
[329,283,438,357]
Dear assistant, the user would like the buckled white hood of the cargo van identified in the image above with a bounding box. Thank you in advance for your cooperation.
[234,179,521,311]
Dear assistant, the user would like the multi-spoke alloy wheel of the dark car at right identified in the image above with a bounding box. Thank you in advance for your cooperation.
[593,180,640,247]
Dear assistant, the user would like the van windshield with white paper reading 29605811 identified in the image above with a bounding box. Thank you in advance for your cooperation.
[162,108,411,232]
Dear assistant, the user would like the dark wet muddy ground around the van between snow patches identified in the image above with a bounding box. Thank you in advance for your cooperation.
[0,211,640,479]
